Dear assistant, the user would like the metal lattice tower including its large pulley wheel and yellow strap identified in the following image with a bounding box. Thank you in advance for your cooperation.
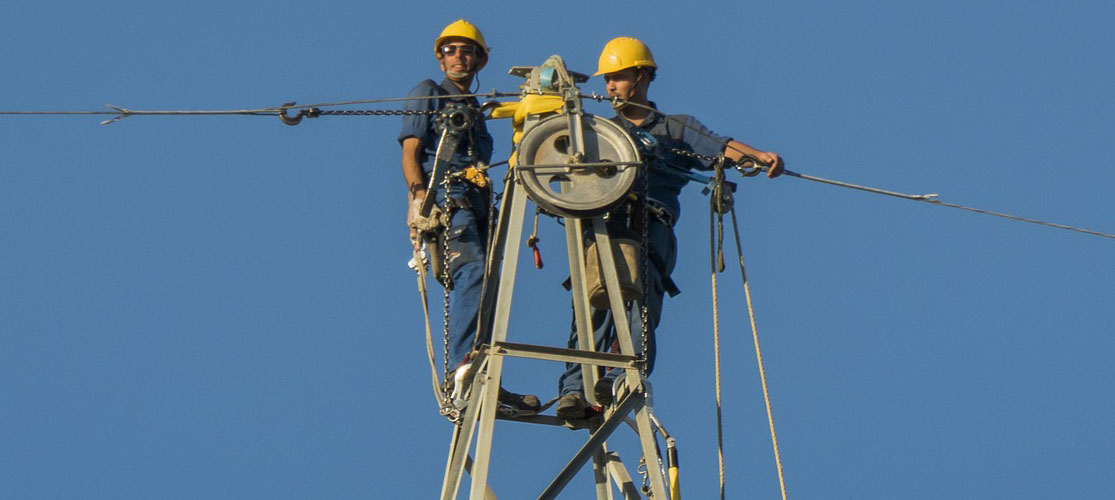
[439,56,680,500]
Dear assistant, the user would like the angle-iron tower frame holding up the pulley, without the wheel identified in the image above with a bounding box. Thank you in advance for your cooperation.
[440,56,669,500]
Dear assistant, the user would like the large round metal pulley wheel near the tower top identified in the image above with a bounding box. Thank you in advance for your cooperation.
[515,115,640,218]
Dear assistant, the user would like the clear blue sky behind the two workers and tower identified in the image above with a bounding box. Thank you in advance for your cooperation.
[0,1,1115,499]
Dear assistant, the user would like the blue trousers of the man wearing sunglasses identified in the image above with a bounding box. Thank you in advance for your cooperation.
[434,183,492,369]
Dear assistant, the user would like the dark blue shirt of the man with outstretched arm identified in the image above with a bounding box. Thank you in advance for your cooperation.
[612,103,731,221]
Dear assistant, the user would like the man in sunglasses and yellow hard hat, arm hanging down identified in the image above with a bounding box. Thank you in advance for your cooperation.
[398,19,539,411]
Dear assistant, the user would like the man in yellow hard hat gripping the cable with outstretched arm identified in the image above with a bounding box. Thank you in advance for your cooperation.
[556,37,784,419]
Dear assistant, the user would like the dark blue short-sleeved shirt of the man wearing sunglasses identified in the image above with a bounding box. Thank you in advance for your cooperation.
[399,78,493,173]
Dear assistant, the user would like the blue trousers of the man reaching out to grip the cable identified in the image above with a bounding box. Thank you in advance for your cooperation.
[558,219,678,395]
